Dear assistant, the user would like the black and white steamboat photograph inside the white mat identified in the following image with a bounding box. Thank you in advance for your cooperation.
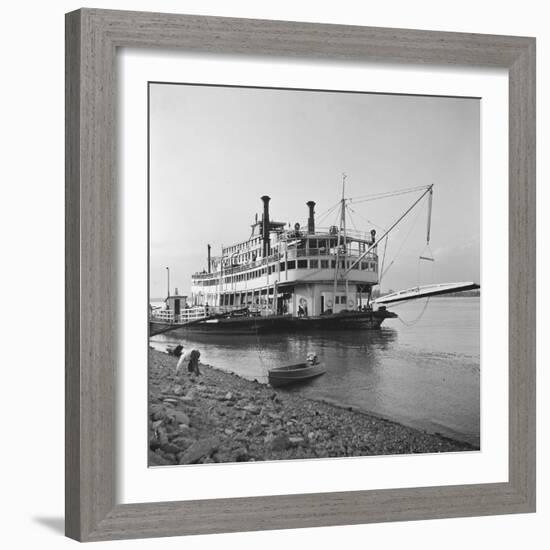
[148,82,482,467]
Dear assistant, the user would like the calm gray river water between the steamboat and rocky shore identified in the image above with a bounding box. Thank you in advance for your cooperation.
[151,298,480,444]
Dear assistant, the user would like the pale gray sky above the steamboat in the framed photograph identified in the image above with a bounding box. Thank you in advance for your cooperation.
[149,83,480,298]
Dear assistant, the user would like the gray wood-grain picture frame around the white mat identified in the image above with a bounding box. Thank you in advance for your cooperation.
[65,9,535,541]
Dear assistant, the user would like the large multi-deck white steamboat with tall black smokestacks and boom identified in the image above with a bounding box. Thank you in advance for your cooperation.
[150,182,479,335]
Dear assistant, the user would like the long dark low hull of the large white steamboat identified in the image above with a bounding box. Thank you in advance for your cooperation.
[149,310,397,336]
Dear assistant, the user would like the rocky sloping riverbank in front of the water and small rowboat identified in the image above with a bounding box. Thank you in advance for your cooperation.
[149,350,476,466]
